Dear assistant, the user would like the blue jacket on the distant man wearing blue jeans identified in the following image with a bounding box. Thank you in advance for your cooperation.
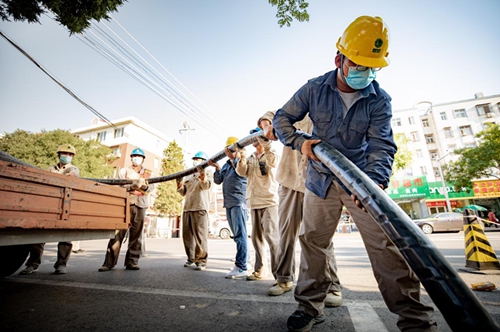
[214,158,247,209]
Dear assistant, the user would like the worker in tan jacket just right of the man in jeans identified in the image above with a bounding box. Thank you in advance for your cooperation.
[236,127,279,280]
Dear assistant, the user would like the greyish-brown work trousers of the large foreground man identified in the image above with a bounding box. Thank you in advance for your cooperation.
[295,182,436,331]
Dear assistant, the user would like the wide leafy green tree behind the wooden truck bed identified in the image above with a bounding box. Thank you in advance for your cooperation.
[0,129,116,178]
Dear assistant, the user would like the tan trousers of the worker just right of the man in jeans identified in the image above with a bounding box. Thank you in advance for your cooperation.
[250,205,279,280]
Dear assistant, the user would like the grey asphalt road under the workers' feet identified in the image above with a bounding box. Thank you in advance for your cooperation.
[0,232,500,332]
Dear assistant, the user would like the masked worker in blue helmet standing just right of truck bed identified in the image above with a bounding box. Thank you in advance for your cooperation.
[99,148,154,272]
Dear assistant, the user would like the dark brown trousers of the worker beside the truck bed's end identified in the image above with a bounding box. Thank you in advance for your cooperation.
[103,205,147,268]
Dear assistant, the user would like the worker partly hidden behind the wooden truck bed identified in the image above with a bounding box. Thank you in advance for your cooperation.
[19,144,80,275]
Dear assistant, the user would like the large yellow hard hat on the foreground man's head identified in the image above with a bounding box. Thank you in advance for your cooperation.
[337,16,390,68]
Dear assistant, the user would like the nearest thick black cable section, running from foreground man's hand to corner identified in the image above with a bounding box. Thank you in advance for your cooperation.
[313,142,500,331]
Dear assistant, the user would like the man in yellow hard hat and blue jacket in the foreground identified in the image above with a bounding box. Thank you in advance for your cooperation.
[273,16,437,331]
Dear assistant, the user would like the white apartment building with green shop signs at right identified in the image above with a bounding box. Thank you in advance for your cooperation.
[387,93,500,218]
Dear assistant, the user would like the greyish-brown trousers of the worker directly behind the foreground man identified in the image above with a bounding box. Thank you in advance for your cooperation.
[276,185,341,291]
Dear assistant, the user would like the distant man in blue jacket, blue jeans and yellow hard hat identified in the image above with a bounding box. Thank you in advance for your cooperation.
[208,137,248,279]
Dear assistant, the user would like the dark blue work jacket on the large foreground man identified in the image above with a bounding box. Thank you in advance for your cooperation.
[273,70,397,198]
